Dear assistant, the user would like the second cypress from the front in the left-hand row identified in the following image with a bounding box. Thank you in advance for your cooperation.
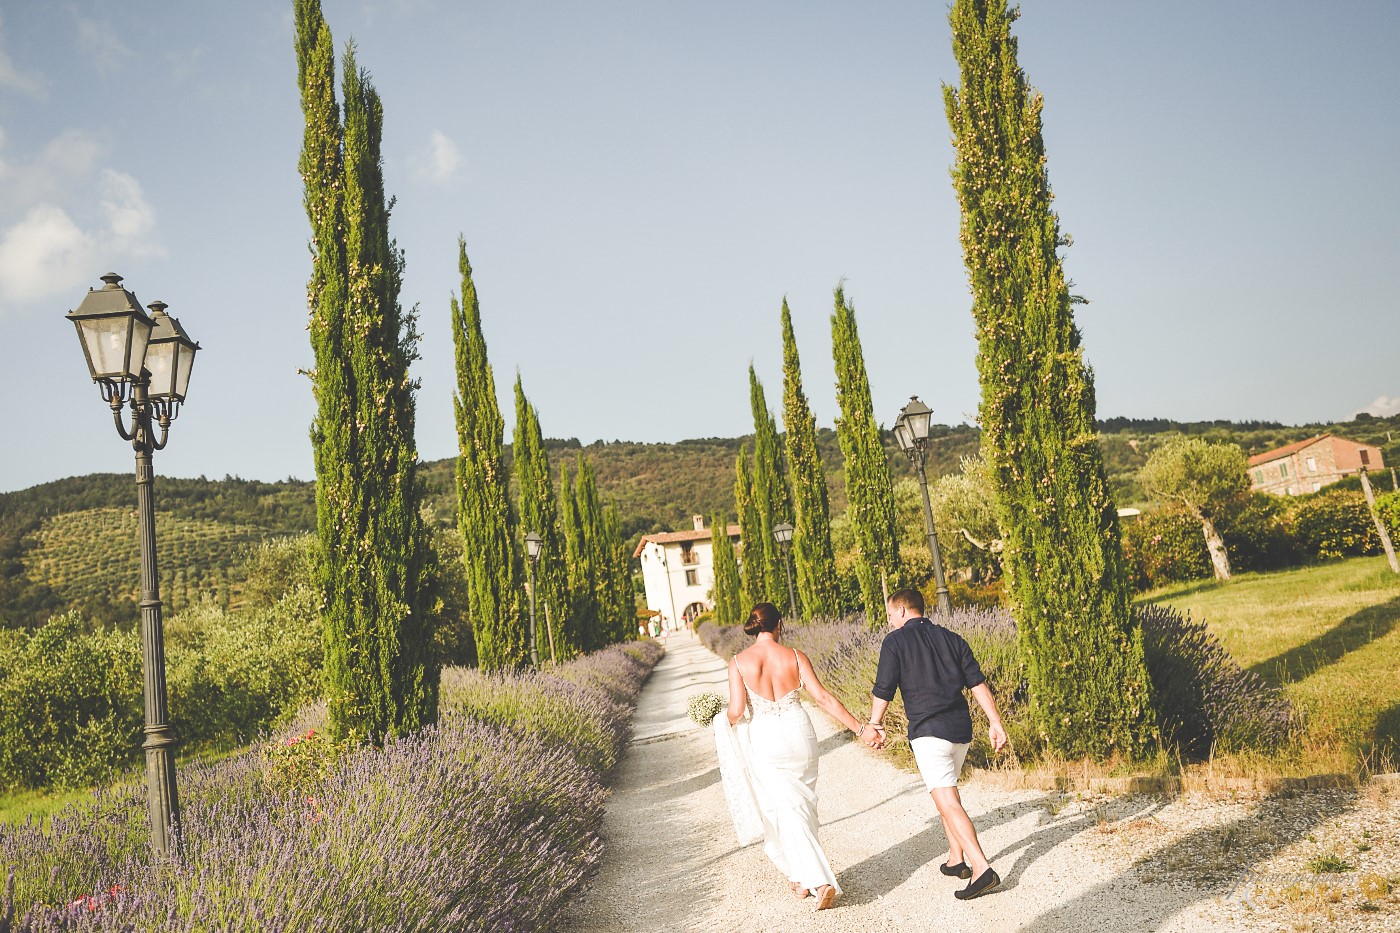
[452,238,528,670]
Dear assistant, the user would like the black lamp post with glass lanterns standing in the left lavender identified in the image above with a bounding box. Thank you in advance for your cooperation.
[67,272,199,856]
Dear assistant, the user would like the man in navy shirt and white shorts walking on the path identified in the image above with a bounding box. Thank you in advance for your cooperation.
[869,590,1007,901]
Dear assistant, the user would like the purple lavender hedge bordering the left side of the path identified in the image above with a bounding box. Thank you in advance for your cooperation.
[0,643,661,933]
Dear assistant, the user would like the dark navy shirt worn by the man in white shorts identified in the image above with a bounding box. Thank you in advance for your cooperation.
[871,618,987,742]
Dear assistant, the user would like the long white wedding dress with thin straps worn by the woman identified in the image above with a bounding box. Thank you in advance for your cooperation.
[713,650,841,892]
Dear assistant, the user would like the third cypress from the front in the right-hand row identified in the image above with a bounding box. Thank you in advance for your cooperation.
[783,298,840,618]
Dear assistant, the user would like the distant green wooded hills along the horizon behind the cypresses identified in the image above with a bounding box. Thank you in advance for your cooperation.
[0,416,1400,628]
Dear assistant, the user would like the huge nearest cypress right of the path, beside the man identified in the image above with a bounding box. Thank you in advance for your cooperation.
[944,0,1152,755]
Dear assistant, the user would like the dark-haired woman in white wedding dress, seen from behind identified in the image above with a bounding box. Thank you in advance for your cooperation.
[721,602,881,911]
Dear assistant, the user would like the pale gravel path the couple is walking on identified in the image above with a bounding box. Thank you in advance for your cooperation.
[568,633,1400,933]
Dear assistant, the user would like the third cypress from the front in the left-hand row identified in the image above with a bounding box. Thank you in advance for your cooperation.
[511,373,580,652]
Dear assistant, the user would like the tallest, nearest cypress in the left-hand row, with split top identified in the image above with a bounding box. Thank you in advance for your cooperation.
[295,0,438,741]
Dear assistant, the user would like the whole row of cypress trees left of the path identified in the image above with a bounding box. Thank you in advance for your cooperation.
[294,0,636,742]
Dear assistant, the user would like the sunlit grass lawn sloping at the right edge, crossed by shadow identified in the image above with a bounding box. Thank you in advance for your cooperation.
[1141,558,1400,770]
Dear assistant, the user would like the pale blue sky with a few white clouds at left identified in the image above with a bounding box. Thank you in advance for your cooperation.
[0,0,1400,490]
